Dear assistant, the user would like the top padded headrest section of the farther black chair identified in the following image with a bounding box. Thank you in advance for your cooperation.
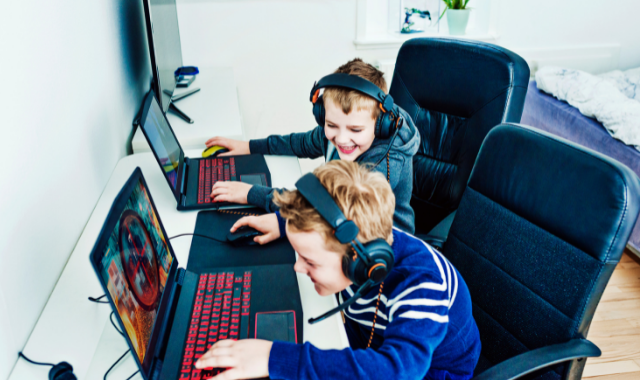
[393,38,529,117]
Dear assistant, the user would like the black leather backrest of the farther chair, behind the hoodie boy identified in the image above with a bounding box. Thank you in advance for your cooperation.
[389,38,529,233]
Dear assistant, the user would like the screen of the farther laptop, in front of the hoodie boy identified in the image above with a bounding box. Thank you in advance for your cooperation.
[142,95,182,192]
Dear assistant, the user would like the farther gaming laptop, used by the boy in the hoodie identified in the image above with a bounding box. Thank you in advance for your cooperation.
[139,90,271,210]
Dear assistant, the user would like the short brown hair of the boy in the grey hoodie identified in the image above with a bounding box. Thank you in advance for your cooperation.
[322,58,388,121]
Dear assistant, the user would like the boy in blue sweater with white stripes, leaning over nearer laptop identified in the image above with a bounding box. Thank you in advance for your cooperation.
[196,161,480,379]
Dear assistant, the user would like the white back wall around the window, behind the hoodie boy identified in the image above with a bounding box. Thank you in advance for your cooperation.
[177,0,640,171]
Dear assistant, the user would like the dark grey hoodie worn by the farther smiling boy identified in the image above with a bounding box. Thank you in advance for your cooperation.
[247,105,420,234]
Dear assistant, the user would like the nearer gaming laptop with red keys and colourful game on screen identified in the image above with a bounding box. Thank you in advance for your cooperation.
[90,168,302,380]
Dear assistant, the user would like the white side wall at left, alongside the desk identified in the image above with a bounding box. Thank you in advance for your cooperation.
[0,0,151,379]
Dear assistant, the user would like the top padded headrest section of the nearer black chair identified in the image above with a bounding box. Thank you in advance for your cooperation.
[468,124,640,261]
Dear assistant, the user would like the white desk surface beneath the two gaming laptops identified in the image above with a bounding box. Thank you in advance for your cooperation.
[9,150,348,380]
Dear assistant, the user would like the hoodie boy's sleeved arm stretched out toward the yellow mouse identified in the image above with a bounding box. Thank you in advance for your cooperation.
[249,126,326,158]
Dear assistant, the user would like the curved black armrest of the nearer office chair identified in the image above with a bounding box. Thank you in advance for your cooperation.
[473,339,602,380]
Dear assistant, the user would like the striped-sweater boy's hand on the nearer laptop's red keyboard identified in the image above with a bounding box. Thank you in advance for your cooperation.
[196,339,273,380]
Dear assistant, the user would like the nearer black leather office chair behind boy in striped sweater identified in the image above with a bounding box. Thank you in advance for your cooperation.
[443,124,640,380]
